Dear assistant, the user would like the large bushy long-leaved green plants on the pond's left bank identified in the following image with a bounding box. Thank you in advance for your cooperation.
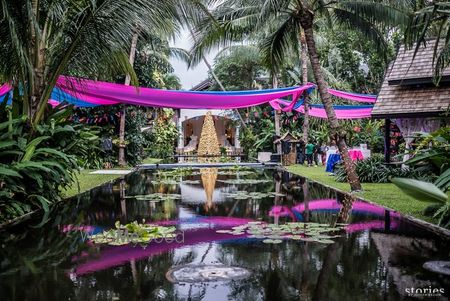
[0,115,78,221]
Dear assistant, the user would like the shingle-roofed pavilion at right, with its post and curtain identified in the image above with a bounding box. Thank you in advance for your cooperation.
[372,40,450,162]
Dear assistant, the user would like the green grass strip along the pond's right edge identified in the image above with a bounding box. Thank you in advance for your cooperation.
[287,165,433,222]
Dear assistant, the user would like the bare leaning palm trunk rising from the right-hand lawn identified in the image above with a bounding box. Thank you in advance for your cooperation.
[299,6,361,191]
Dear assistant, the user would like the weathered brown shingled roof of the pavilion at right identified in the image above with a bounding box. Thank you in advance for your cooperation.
[372,41,450,118]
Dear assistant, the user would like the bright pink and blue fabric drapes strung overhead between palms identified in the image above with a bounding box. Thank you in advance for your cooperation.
[0,76,376,119]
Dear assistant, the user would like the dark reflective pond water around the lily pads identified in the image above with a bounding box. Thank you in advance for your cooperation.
[0,168,450,301]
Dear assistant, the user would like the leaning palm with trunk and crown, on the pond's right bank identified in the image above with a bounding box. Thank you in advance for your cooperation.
[192,0,384,191]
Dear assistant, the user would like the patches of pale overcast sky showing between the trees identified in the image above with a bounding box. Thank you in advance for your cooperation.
[170,31,217,90]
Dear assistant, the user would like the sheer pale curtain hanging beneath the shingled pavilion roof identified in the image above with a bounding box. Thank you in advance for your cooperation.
[395,118,440,162]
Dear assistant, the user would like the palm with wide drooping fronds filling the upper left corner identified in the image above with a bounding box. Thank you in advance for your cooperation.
[0,0,179,126]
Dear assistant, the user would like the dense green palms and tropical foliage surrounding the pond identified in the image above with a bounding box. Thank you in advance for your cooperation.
[0,0,450,226]
